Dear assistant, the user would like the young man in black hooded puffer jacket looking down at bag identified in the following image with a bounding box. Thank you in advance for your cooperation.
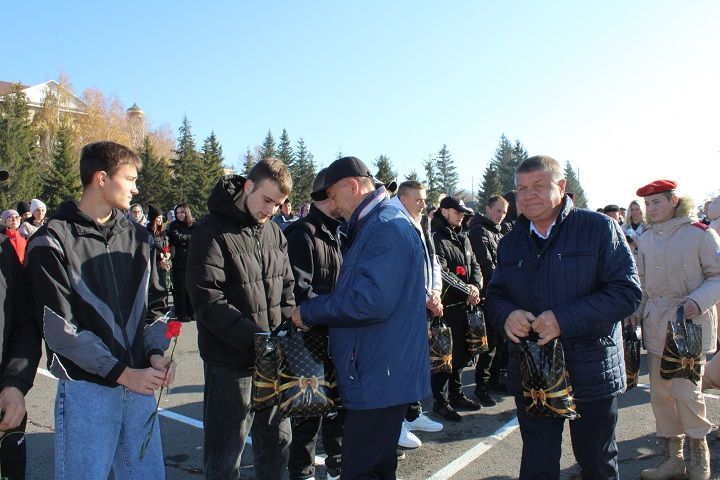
[186,159,295,480]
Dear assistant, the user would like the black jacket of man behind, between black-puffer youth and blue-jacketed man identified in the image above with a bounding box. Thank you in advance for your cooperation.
[283,204,342,305]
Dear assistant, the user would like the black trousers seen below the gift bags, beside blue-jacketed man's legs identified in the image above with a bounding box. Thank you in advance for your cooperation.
[288,410,345,480]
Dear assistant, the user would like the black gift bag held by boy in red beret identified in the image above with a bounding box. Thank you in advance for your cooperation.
[660,306,705,385]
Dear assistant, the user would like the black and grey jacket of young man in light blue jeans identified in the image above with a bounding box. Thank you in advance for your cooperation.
[26,202,169,387]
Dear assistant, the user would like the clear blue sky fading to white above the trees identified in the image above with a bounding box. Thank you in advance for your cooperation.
[0,0,720,208]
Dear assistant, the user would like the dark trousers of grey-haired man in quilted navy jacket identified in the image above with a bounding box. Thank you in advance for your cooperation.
[515,397,620,480]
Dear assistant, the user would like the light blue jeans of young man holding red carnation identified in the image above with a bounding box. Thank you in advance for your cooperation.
[55,380,165,480]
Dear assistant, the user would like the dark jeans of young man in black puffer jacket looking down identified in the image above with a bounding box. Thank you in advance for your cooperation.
[203,363,292,480]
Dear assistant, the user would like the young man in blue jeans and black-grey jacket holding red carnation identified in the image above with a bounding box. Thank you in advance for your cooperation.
[27,142,175,479]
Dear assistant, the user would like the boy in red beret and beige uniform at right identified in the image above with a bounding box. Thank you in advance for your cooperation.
[630,180,720,480]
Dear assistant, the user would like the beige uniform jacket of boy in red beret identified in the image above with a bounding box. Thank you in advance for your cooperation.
[637,216,720,355]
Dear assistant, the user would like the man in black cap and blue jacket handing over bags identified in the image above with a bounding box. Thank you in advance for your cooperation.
[293,157,430,479]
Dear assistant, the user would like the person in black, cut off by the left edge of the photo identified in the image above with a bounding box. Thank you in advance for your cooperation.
[0,171,41,480]
